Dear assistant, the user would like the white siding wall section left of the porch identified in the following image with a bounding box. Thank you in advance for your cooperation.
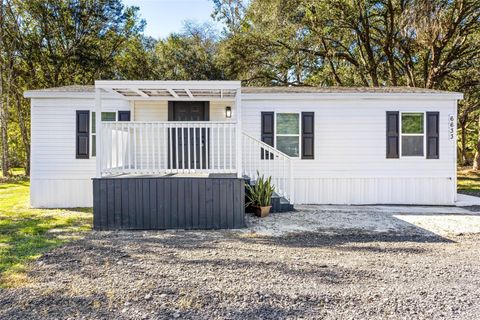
[30,96,130,208]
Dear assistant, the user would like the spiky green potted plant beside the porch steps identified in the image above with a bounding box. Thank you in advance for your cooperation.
[246,175,275,218]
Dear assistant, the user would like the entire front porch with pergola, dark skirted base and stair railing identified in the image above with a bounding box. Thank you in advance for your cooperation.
[93,81,293,230]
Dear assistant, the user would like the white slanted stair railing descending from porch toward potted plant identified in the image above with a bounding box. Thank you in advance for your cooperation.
[242,132,294,203]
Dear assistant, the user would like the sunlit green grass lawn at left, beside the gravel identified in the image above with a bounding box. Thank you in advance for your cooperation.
[0,170,92,288]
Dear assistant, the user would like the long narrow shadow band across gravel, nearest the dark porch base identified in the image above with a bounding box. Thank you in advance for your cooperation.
[89,230,455,257]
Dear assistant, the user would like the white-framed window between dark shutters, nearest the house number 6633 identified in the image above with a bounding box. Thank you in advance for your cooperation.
[400,112,426,157]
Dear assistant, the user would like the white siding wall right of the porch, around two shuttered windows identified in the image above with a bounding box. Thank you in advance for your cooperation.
[242,94,456,205]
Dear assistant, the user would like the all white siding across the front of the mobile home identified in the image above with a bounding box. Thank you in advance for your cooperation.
[31,94,456,207]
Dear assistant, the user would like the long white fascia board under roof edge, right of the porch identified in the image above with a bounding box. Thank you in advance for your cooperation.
[242,92,463,100]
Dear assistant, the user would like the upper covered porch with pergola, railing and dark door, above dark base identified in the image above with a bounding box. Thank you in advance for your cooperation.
[95,81,242,178]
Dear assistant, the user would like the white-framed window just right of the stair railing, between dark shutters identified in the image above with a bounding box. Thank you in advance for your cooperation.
[275,113,301,158]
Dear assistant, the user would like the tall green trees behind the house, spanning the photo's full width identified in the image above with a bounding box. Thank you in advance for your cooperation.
[0,0,480,172]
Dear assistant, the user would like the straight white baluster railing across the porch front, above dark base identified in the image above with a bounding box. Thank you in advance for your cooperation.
[101,121,237,175]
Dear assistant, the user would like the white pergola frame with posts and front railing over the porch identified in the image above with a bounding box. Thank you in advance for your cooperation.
[95,80,242,178]
